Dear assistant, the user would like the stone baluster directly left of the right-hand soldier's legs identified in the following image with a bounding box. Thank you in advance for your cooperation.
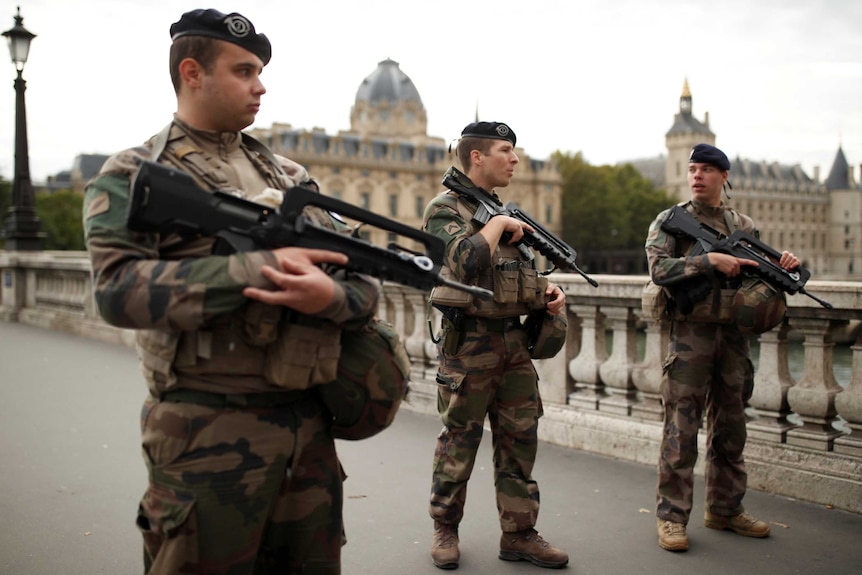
[632,321,670,421]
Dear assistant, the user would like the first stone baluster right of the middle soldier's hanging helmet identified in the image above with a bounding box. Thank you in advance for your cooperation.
[569,304,608,410]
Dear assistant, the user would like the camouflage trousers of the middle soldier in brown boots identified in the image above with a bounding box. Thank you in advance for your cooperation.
[429,329,542,532]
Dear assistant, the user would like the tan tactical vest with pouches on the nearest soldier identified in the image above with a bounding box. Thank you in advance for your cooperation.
[137,122,341,393]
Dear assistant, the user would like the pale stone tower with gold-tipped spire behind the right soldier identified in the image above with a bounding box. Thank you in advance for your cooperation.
[665,79,715,202]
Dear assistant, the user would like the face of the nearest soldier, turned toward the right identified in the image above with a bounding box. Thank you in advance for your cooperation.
[201,42,266,132]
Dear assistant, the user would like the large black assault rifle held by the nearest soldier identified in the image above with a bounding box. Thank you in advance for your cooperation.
[127,161,493,298]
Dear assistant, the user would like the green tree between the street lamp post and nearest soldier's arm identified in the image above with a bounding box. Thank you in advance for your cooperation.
[36,190,84,250]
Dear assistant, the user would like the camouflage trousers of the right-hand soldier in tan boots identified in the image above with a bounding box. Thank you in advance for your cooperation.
[656,322,754,524]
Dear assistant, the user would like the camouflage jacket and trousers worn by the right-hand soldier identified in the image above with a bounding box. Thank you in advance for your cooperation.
[645,202,757,524]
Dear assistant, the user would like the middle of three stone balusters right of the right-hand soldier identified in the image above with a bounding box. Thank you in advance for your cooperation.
[787,318,841,451]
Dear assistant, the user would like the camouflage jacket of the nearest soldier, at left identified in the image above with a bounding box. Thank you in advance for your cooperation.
[83,120,379,392]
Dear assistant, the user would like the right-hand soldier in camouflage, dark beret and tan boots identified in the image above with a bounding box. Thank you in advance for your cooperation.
[646,144,799,551]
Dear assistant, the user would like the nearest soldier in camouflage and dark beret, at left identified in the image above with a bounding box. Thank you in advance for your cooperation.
[84,10,379,575]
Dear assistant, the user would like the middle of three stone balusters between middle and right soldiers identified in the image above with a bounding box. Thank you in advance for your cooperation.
[599,306,637,415]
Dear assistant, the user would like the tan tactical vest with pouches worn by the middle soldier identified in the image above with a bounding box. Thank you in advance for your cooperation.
[429,192,548,318]
